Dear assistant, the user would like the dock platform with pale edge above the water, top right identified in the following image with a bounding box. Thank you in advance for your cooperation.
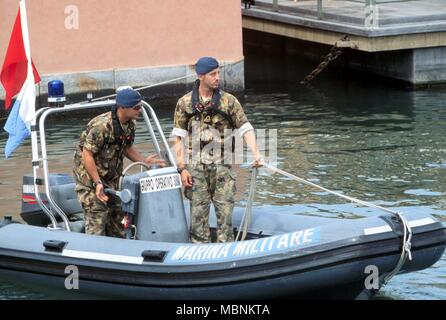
[242,0,446,86]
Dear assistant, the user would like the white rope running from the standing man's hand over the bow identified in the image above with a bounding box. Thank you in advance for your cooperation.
[264,163,412,286]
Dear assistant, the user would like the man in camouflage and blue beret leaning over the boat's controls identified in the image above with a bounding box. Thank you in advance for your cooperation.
[73,87,164,238]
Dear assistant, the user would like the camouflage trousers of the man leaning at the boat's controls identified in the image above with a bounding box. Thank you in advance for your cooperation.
[76,187,125,238]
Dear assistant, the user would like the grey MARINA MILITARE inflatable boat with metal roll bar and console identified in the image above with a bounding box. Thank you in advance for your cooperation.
[0,100,446,299]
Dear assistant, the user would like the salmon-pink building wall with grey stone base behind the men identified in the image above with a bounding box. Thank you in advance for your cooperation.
[0,0,244,98]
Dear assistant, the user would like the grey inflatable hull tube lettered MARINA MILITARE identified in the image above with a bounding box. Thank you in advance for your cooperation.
[0,210,446,300]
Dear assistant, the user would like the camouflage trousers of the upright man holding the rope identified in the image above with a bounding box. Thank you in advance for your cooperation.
[185,164,236,243]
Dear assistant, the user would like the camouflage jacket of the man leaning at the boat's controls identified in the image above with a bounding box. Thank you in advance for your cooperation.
[73,112,135,188]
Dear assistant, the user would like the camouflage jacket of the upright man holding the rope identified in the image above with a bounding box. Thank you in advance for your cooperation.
[172,90,253,162]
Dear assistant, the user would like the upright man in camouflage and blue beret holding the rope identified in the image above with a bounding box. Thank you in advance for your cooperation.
[172,57,263,243]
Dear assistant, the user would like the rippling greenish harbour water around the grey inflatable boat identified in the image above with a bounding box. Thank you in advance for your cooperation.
[0,52,446,299]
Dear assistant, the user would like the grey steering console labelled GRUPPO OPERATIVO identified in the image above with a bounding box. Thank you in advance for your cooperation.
[122,167,189,243]
